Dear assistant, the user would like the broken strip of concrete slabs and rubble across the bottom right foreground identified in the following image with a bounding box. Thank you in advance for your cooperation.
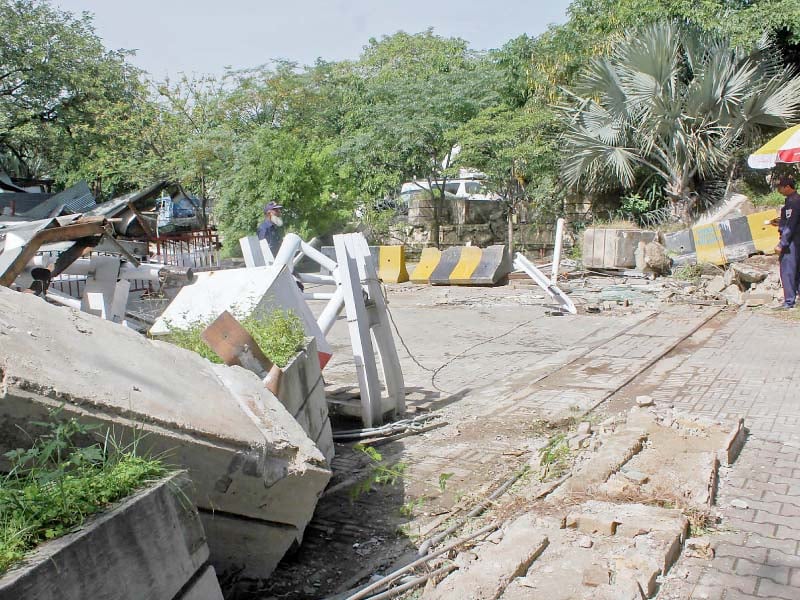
[412,406,746,600]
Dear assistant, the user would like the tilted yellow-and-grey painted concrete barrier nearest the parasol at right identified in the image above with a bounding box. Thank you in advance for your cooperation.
[664,209,778,265]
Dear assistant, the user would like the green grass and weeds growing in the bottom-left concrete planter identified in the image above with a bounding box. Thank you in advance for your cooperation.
[0,411,166,574]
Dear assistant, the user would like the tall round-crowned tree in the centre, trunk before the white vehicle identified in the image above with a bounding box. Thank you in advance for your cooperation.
[339,30,497,245]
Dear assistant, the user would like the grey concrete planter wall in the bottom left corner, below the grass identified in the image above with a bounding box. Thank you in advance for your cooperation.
[0,473,222,600]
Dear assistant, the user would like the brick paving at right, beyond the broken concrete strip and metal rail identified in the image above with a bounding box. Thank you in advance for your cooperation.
[656,312,800,600]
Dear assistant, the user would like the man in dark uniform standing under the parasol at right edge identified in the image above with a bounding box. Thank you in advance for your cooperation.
[775,176,800,310]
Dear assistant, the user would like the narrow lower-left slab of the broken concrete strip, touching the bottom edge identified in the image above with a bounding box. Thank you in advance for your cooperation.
[422,515,549,600]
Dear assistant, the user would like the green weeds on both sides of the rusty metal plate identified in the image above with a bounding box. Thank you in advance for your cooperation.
[164,309,305,368]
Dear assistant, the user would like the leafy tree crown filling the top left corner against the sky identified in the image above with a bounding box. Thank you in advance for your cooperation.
[0,0,142,185]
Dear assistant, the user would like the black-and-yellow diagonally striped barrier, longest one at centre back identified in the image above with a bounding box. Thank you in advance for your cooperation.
[411,245,511,285]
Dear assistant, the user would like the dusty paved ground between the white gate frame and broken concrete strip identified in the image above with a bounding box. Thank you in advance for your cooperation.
[222,277,756,600]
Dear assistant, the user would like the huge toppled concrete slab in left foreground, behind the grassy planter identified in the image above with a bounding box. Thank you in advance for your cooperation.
[0,288,331,577]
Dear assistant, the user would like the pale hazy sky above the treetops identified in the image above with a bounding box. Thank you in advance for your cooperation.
[52,0,570,78]
